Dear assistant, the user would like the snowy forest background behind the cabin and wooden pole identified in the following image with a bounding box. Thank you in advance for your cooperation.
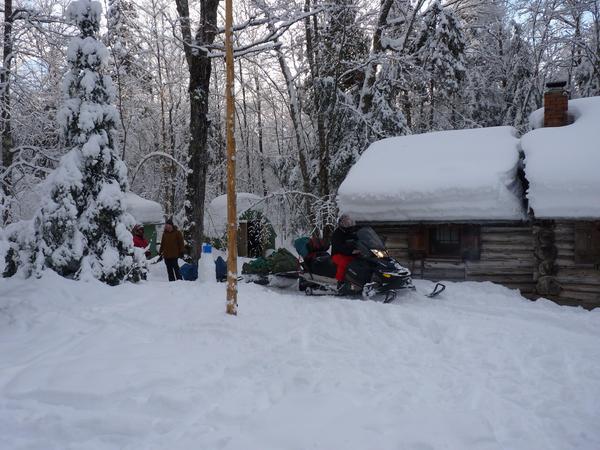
[0,0,600,256]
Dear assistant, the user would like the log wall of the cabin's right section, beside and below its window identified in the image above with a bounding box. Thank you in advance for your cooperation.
[550,221,600,309]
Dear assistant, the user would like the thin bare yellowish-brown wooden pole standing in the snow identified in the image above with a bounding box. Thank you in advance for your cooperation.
[225,0,237,315]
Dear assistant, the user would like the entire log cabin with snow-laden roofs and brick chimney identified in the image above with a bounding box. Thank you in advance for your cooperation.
[338,83,600,309]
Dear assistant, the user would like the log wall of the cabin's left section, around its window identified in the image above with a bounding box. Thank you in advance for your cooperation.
[371,224,536,298]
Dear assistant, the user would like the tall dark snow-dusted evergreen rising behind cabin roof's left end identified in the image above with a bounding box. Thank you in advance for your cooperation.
[306,0,367,197]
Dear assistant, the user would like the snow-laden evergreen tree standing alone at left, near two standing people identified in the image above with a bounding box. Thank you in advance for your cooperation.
[33,0,145,284]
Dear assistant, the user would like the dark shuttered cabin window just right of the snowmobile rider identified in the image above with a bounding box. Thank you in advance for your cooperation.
[408,224,481,260]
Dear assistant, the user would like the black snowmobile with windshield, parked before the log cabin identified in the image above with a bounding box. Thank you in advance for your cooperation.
[298,227,445,303]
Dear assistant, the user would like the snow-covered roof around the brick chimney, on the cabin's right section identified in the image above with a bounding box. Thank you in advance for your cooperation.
[521,97,600,219]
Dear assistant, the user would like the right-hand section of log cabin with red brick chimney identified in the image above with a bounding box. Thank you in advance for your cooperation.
[521,82,600,309]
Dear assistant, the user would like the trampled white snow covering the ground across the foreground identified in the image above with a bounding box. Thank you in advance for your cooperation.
[0,264,600,450]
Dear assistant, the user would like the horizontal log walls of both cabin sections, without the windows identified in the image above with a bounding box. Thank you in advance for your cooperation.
[372,221,600,309]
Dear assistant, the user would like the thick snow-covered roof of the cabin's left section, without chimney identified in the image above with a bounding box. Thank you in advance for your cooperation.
[338,127,525,222]
